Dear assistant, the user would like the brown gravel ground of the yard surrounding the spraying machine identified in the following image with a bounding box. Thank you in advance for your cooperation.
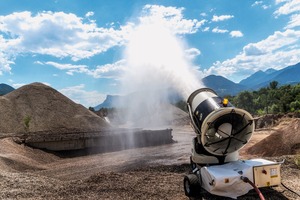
[0,124,300,200]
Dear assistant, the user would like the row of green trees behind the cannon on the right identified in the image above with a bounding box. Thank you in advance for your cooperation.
[226,81,300,115]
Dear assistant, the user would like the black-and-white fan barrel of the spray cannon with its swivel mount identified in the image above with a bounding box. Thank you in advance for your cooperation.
[187,88,254,165]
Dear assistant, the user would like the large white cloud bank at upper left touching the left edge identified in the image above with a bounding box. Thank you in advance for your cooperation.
[0,11,130,71]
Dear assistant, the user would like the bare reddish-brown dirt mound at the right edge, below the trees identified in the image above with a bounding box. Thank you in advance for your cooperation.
[247,118,300,157]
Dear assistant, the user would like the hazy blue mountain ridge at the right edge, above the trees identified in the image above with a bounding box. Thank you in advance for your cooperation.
[239,63,300,90]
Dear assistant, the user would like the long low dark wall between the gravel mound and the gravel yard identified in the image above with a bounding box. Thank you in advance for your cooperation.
[25,129,173,151]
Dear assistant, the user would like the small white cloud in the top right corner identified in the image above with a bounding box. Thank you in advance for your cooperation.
[274,0,300,16]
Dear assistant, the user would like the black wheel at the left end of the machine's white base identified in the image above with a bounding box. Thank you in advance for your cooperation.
[183,174,200,197]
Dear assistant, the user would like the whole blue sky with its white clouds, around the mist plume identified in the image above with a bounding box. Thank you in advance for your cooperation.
[0,0,300,107]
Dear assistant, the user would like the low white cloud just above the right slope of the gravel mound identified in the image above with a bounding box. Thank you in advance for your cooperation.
[59,84,106,108]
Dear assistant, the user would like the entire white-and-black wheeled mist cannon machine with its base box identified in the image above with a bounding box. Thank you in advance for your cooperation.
[183,88,281,199]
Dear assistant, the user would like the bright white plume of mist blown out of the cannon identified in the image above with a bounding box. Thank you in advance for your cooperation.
[122,23,202,128]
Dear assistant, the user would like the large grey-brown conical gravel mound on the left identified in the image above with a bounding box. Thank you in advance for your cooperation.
[0,83,108,133]
